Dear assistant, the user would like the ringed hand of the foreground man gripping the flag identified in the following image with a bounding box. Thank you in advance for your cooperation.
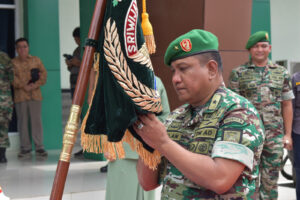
[133,113,170,149]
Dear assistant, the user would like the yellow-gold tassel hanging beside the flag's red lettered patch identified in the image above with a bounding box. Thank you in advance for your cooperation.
[141,0,156,54]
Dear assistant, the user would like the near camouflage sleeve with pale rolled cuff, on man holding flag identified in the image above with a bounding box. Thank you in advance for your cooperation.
[212,109,264,170]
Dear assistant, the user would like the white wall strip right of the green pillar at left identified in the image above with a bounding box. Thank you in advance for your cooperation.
[58,0,80,89]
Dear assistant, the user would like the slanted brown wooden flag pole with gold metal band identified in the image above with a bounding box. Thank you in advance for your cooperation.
[50,0,106,200]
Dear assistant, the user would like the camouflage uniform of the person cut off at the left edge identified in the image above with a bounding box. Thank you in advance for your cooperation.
[0,51,13,148]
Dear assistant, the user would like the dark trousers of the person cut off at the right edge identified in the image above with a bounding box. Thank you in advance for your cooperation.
[293,133,300,200]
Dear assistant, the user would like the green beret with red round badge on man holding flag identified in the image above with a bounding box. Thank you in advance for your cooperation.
[164,29,219,66]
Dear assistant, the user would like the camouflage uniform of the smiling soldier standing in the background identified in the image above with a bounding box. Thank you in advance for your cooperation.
[229,61,294,199]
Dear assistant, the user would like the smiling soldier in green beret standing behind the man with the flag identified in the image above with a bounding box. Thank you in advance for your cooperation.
[229,31,294,199]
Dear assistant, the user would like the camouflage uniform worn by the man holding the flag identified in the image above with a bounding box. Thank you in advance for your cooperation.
[160,86,264,200]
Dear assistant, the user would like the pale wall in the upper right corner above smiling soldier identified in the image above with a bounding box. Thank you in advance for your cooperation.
[270,0,300,73]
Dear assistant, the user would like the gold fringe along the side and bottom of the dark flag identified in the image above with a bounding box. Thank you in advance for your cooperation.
[81,53,161,170]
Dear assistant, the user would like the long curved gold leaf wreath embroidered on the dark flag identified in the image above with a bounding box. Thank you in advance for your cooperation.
[103,19,162,113]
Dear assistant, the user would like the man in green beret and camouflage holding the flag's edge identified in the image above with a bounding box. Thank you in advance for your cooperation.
[134,29,264,200]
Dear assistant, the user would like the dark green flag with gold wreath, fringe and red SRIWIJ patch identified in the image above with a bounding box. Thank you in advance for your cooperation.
[81,0,162,169]
